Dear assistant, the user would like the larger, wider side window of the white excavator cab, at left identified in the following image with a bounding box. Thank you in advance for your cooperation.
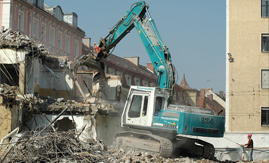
[128,95,142,118]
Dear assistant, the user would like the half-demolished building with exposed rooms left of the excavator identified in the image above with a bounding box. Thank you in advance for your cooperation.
[0,30,119,158]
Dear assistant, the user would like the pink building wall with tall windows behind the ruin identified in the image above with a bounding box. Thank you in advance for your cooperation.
[0,0,85,61]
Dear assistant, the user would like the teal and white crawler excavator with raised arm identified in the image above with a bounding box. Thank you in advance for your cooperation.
[76,1,225,159]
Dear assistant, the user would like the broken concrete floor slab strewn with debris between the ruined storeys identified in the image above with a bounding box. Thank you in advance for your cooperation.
[0,84,119,115]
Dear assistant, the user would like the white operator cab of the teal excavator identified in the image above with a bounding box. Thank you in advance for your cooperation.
[121,86,169,127]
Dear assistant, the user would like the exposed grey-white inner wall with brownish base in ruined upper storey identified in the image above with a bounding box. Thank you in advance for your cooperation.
[26,57,73,99]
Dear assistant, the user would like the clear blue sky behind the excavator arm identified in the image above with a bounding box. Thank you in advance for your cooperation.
[45,0,226,93]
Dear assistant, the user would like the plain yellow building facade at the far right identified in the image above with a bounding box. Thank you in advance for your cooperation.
[226,0,269,133]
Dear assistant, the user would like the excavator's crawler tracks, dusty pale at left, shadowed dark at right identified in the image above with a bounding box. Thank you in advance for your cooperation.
[114,131,215,160]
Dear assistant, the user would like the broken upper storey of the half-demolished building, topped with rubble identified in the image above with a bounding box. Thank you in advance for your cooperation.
[0,29,73,99]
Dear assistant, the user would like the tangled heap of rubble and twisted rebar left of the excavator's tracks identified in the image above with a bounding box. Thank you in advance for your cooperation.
[4,130,112,162]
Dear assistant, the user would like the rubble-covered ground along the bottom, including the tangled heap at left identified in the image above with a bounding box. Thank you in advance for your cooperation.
[3,131,269,163]
